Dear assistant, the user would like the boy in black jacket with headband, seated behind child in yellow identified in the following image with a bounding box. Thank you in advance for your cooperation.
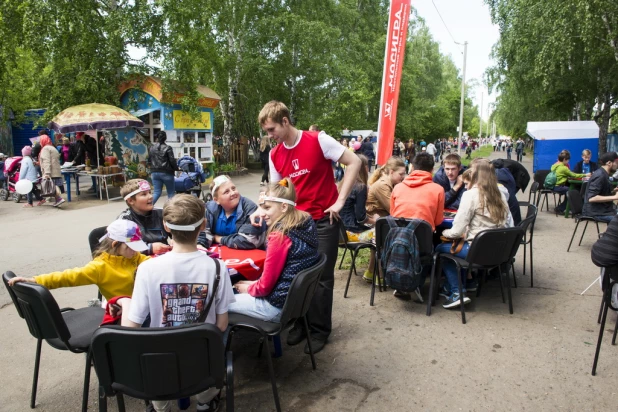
[118,179,172,255]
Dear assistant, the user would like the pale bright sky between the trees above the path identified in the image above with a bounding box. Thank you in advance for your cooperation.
[412,0,500,119]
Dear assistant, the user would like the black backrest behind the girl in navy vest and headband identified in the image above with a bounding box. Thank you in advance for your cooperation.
[280,253,326,326]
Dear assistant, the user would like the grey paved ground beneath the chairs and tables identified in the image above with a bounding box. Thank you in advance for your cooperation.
[0,156,618,411]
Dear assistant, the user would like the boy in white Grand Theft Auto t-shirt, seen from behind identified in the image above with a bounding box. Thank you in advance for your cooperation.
[117,195,236,412]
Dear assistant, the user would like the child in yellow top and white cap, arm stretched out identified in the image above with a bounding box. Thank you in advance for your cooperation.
[9,220,149,300]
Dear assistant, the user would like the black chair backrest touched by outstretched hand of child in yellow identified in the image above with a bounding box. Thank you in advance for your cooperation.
[2,271,71,342]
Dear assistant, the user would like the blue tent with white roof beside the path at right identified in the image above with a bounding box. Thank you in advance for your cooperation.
[526,120,599,172]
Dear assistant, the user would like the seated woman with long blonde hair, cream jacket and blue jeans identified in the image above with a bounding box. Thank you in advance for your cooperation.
[436,162,509,308]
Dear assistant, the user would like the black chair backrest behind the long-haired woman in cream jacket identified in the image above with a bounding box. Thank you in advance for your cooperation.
[466,226,524,266]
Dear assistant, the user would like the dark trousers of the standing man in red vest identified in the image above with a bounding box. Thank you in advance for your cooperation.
[296,216,339,340]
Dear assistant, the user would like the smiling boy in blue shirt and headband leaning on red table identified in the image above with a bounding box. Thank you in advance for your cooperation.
[197,175,265,250]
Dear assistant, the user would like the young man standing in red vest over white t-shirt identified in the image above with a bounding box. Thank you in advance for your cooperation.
[251,100,361,353]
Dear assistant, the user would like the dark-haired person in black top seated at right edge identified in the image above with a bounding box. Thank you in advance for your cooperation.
[583,152,618,223]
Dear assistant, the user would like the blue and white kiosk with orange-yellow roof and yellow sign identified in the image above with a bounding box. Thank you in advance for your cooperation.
[113,76,221,178]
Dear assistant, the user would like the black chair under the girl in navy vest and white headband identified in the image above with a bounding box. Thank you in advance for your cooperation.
[226,254,326,412]
